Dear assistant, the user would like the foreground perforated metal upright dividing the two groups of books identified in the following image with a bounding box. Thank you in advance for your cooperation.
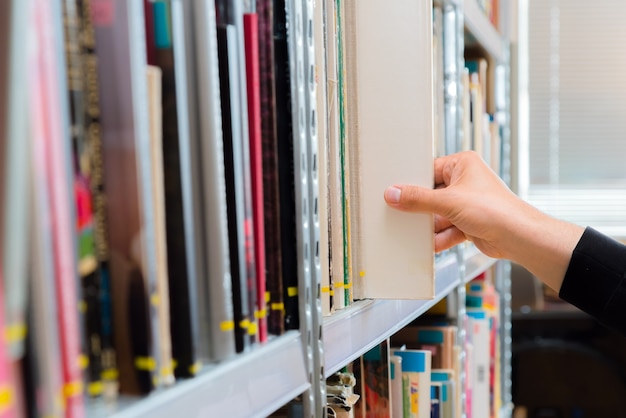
[285,0,325,418]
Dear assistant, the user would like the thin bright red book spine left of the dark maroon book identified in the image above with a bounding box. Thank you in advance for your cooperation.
[243,13,267,342]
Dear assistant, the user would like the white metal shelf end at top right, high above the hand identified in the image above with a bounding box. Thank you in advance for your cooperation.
[463,0,505,62]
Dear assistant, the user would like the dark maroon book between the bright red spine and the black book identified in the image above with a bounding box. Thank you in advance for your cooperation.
[256,0,285,335]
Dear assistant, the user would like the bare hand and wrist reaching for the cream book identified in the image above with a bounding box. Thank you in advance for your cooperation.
[384,151,584,291]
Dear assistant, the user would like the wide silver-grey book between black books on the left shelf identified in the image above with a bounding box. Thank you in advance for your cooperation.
[182,0,236,362]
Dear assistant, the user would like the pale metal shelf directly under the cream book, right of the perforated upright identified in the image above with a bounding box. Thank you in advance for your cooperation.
[323,254,459,376]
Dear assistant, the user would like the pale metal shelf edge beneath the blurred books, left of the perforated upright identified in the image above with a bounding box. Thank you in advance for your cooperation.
[87,331,310,418]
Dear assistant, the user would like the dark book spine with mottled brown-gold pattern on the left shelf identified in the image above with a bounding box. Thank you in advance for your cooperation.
[79,0,117,395]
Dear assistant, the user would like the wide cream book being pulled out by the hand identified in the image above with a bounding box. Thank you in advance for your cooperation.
[343,0,434,299]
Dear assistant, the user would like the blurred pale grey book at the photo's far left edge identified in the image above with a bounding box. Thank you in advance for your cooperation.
[0,0,32,360]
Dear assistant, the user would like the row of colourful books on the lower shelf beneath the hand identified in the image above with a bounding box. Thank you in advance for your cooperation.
[327,274,501,418]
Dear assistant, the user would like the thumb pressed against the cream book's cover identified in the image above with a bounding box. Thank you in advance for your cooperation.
[385,184,447,214]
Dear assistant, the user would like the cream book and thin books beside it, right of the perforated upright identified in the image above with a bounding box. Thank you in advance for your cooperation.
[313,0,434,315]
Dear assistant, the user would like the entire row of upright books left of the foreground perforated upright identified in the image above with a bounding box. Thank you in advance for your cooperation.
[0,0,308,417]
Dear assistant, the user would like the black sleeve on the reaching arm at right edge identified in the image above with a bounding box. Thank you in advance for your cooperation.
[559,228,626,335]
